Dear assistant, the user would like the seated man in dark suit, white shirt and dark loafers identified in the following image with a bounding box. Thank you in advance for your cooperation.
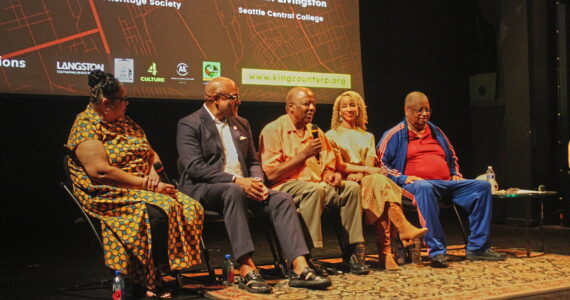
[177,77,331,293]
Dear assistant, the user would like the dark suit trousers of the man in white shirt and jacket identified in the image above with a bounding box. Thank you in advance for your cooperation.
[200,183,309,263]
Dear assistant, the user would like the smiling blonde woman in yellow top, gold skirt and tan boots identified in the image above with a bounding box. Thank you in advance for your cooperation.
[326,91,427,270]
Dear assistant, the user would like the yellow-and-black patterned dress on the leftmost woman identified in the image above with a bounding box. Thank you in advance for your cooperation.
[66,105,204,289]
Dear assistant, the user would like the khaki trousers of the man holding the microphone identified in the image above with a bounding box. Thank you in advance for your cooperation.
[277,180,364,248]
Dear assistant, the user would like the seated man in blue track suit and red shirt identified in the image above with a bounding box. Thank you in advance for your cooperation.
[377,92,505,268]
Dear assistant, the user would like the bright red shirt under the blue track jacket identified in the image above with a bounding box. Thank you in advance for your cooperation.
[404,126,451,180]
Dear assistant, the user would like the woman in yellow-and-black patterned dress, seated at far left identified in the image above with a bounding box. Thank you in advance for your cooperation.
[66,70,204,298]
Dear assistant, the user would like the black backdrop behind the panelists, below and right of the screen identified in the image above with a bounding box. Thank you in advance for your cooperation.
[0,0,496,230]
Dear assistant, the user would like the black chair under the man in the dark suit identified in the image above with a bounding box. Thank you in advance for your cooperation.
[176,158,291,283]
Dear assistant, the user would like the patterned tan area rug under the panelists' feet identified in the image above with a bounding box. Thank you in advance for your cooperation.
[197,250,570,300]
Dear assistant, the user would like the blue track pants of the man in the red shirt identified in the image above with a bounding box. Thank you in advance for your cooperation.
[403,180,492,256]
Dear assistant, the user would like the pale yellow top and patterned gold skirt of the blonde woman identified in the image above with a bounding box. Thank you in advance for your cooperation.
[326,126,402,224]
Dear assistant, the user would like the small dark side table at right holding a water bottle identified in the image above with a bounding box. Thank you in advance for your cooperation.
[493,190,558,257]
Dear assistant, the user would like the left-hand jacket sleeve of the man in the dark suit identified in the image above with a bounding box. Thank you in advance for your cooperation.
[176,119,233,183]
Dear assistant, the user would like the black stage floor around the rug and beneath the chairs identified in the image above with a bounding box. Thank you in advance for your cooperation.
[0,211,570,300]
